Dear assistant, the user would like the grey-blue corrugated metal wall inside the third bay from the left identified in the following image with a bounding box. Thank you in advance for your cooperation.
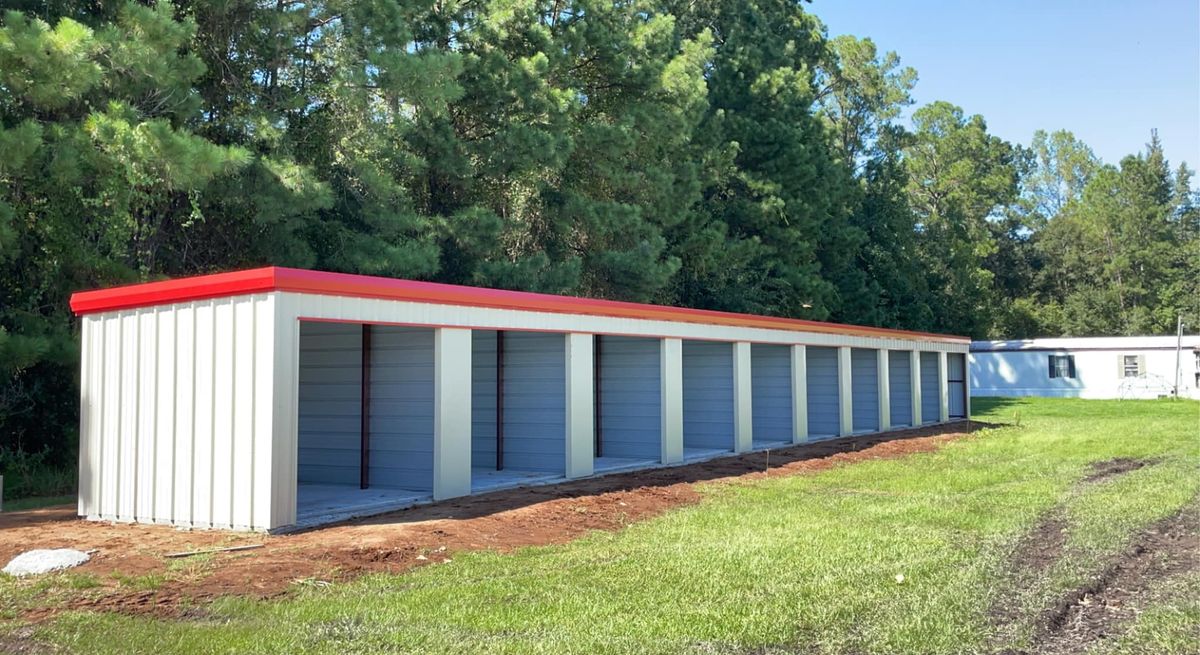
[599,336,662,461]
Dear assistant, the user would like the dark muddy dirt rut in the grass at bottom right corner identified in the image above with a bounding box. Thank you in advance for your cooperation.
[1033,503,1200,655]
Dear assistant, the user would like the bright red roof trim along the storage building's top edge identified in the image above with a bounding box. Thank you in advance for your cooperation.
[71,266,970,343]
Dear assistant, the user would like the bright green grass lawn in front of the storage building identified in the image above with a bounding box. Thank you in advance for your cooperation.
[0,399,1200,654]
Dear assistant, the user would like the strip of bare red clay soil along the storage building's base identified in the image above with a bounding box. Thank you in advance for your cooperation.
[0,422,983,620]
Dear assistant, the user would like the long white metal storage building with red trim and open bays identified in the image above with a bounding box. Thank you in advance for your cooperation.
[71,268,970,530]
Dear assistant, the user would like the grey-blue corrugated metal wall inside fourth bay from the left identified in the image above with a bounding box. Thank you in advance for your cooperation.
[683,341,733,450]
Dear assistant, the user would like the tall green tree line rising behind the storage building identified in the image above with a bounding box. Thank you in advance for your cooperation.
[0,0,1200,470]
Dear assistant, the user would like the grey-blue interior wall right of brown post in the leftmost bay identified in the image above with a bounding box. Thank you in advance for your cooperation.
[370,325,433,492]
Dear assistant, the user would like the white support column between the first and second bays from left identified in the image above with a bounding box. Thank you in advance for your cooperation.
[433,328,472,500]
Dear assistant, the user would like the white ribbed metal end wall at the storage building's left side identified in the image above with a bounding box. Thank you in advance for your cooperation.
[79,294,275,529]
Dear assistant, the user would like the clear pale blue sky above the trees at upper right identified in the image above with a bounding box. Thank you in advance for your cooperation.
[806,0,1200,171]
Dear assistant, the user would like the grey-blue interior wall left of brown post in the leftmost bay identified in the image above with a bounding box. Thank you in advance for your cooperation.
[296,322,362,486]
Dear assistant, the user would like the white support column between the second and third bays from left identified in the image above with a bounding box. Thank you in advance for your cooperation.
[566,332,595,479]
